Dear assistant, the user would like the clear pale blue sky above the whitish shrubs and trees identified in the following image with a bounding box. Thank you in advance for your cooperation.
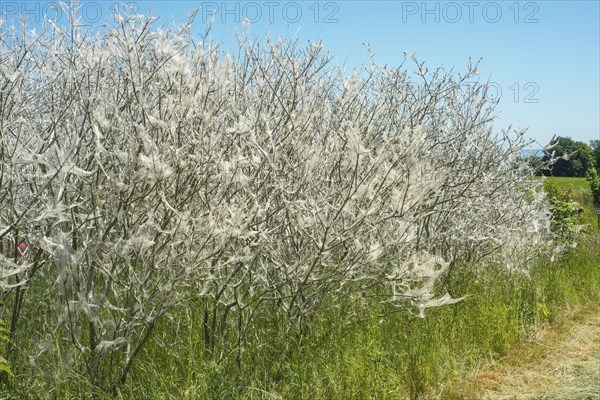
[0,0,600,144]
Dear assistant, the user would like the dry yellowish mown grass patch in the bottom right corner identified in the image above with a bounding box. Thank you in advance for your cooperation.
[436,304,600,400]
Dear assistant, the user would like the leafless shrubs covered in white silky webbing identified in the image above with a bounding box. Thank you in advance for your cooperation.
[0,7,552,396]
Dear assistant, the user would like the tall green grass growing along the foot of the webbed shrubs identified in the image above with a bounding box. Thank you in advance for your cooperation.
[5,178,600,400]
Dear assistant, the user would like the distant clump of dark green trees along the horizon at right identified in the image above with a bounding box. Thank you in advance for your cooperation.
[529,136,600,177]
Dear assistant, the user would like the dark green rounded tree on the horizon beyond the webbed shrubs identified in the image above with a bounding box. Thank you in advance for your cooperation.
[542,136,595,177]
